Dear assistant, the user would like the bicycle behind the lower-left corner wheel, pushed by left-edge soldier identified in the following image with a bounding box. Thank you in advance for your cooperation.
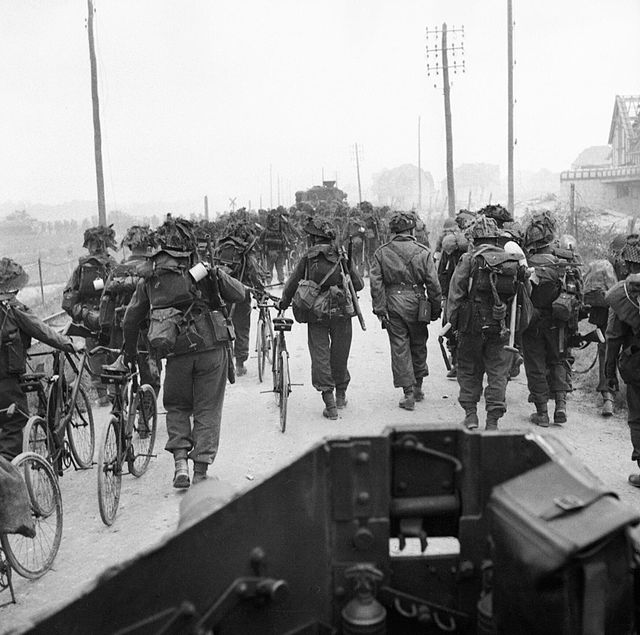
[21,351,95,476]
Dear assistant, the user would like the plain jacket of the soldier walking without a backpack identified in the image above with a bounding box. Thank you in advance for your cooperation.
[370,234,442,321]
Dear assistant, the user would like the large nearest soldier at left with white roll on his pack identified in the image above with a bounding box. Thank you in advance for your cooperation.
[123,218,246,488]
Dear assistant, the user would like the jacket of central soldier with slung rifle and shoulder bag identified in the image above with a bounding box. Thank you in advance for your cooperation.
[280,244,364,320]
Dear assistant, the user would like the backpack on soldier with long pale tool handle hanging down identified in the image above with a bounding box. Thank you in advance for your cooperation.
[471,245,520,302]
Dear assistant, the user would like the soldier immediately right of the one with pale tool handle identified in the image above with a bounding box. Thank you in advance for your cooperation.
[522,212,572,427]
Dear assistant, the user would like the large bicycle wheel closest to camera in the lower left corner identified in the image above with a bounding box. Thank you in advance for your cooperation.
[0,452,62,580]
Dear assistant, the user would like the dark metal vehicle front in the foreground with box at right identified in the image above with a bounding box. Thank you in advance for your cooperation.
[22,425,639,635]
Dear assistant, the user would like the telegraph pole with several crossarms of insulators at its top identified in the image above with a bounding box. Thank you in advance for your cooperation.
[427,22,464,217]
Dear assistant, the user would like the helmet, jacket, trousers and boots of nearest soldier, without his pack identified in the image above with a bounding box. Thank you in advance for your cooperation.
[123,219,246,487]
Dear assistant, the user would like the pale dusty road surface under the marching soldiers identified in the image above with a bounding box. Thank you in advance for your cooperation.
[0,288,640,632]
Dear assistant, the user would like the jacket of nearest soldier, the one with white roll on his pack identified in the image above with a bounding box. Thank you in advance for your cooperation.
[122,268,247,358]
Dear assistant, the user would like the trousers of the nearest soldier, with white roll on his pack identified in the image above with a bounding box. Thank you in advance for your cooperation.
[164,346,228,463]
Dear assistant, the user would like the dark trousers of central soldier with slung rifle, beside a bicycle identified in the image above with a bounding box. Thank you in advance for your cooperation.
[307,317,352,391]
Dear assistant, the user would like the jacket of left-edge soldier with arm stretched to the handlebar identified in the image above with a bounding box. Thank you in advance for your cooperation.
[0,298,74,379]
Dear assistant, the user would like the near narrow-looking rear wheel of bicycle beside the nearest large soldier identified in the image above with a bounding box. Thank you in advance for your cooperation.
[98,417,123,525]
